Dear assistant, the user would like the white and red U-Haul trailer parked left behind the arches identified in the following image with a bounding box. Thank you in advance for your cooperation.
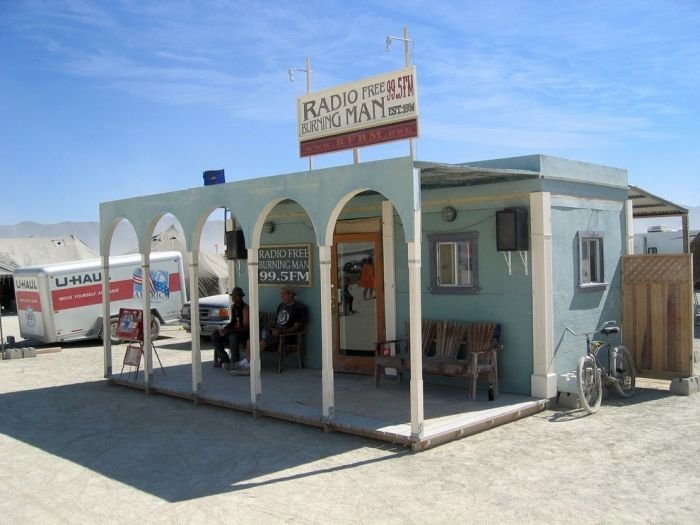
[14,252,186,343]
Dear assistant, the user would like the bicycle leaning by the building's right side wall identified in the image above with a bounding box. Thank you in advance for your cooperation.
[566,321,637,414]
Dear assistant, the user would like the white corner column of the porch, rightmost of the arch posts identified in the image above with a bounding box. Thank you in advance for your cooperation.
[408,203,424,437]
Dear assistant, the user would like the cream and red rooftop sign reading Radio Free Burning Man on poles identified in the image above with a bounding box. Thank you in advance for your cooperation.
[297,67,418,157]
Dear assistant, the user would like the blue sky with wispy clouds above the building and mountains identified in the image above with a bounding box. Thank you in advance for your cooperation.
[0,0,700,225]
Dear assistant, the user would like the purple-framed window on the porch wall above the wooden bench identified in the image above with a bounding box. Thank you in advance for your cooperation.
[428,232,479,294]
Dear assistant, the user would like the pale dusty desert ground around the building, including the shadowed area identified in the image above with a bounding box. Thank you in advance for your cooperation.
[0,314,700,524]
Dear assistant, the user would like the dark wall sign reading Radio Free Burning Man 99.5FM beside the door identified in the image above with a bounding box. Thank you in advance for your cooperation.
[258,244,311,287]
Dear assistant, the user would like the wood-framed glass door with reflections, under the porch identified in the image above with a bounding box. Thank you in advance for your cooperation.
[331,232,384,374]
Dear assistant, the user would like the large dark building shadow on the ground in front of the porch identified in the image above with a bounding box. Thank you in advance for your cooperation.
[0,381,410,502]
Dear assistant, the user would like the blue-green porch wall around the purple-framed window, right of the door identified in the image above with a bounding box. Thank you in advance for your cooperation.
[395,183,532,394]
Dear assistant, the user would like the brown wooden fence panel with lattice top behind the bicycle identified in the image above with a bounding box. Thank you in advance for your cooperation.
[622,253,694,379]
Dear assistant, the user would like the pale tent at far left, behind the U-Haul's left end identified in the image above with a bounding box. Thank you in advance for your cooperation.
[0,235,99,309]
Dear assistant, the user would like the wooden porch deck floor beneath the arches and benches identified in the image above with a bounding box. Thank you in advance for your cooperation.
[111,334,546,450]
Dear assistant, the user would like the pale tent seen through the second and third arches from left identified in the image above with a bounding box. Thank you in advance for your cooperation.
[151,226,228,297]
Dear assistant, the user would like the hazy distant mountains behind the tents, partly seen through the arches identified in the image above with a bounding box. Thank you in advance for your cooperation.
[0,220,224,255]
